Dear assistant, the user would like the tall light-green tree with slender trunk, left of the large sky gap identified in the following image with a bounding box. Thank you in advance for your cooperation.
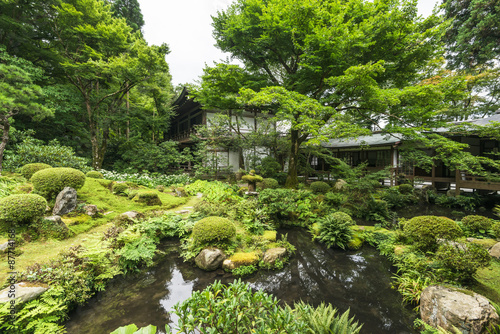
[52,0,169,169]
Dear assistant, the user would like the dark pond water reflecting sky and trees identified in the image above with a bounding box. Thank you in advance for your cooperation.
[66,230,415,334]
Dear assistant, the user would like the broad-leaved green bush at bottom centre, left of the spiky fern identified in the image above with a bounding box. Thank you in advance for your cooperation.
[173,281,306,334]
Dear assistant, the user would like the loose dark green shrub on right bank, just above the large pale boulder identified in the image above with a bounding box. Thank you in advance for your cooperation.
[436,243,491,281]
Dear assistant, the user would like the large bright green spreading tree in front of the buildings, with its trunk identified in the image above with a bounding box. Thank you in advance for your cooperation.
[213,0,444,187]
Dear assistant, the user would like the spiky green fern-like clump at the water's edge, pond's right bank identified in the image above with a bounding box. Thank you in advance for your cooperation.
[317,212,356,249]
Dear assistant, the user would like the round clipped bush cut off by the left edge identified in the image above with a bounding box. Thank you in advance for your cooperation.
[0,194,47,224]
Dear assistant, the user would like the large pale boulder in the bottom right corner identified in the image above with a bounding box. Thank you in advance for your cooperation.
[420,285,499,334]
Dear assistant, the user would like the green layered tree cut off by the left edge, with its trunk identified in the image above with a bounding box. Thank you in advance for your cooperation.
[0,46,52,174]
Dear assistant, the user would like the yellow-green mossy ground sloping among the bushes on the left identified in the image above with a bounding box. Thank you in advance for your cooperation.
[0,174,195,284]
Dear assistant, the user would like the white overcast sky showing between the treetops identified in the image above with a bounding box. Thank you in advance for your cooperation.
[139,0,438,85]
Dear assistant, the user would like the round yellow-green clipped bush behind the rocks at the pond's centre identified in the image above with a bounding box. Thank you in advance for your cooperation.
[192,216,236,244]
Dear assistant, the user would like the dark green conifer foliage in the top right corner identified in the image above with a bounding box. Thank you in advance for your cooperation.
[443,0,500,70]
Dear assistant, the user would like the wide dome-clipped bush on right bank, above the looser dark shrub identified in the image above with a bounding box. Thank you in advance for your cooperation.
[404,216,463,251]
